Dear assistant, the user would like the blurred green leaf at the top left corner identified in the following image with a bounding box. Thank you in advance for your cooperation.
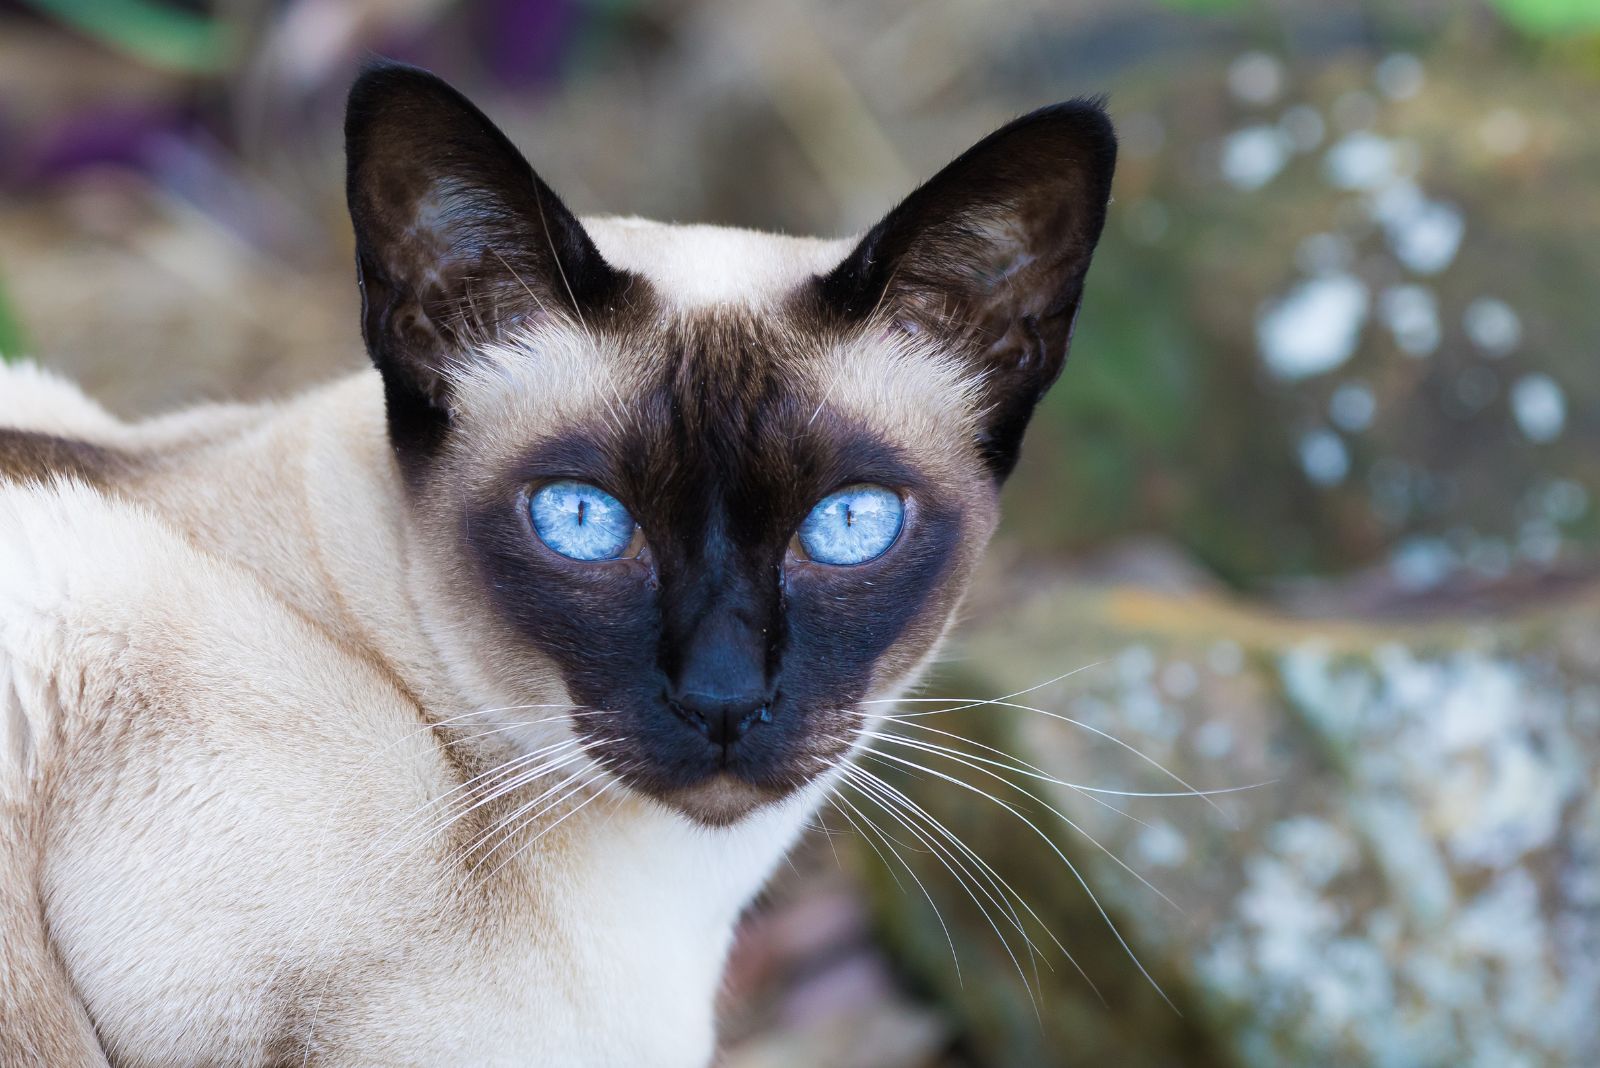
[27,0,230,74]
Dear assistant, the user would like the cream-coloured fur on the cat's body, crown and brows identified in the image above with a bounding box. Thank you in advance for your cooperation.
[0,221,970,1068]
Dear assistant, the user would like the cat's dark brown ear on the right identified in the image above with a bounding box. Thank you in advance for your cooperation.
[821,101,1117,478]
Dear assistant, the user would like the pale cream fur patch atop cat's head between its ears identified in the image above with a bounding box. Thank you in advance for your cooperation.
[584,217,851,313]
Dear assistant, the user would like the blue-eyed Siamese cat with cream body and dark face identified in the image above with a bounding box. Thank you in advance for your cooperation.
[0,64,1115,1066]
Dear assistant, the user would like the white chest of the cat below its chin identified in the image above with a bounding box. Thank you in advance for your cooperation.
[302,791,814,1068]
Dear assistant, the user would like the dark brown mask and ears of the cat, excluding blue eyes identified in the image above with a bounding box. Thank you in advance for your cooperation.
[346,67,1115,822]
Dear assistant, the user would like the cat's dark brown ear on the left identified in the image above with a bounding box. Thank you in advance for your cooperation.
[344,64,627,456]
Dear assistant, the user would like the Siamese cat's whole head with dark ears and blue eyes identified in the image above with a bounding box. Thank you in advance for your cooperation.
[346,66,1115,823]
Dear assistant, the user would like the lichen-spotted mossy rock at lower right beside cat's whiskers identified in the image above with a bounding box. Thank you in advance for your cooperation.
[846,582,1600,1066]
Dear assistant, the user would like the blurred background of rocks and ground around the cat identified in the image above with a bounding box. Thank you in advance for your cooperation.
[0,0,1600,1068]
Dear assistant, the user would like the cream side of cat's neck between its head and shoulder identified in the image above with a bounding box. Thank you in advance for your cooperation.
[126,371,459,710]
